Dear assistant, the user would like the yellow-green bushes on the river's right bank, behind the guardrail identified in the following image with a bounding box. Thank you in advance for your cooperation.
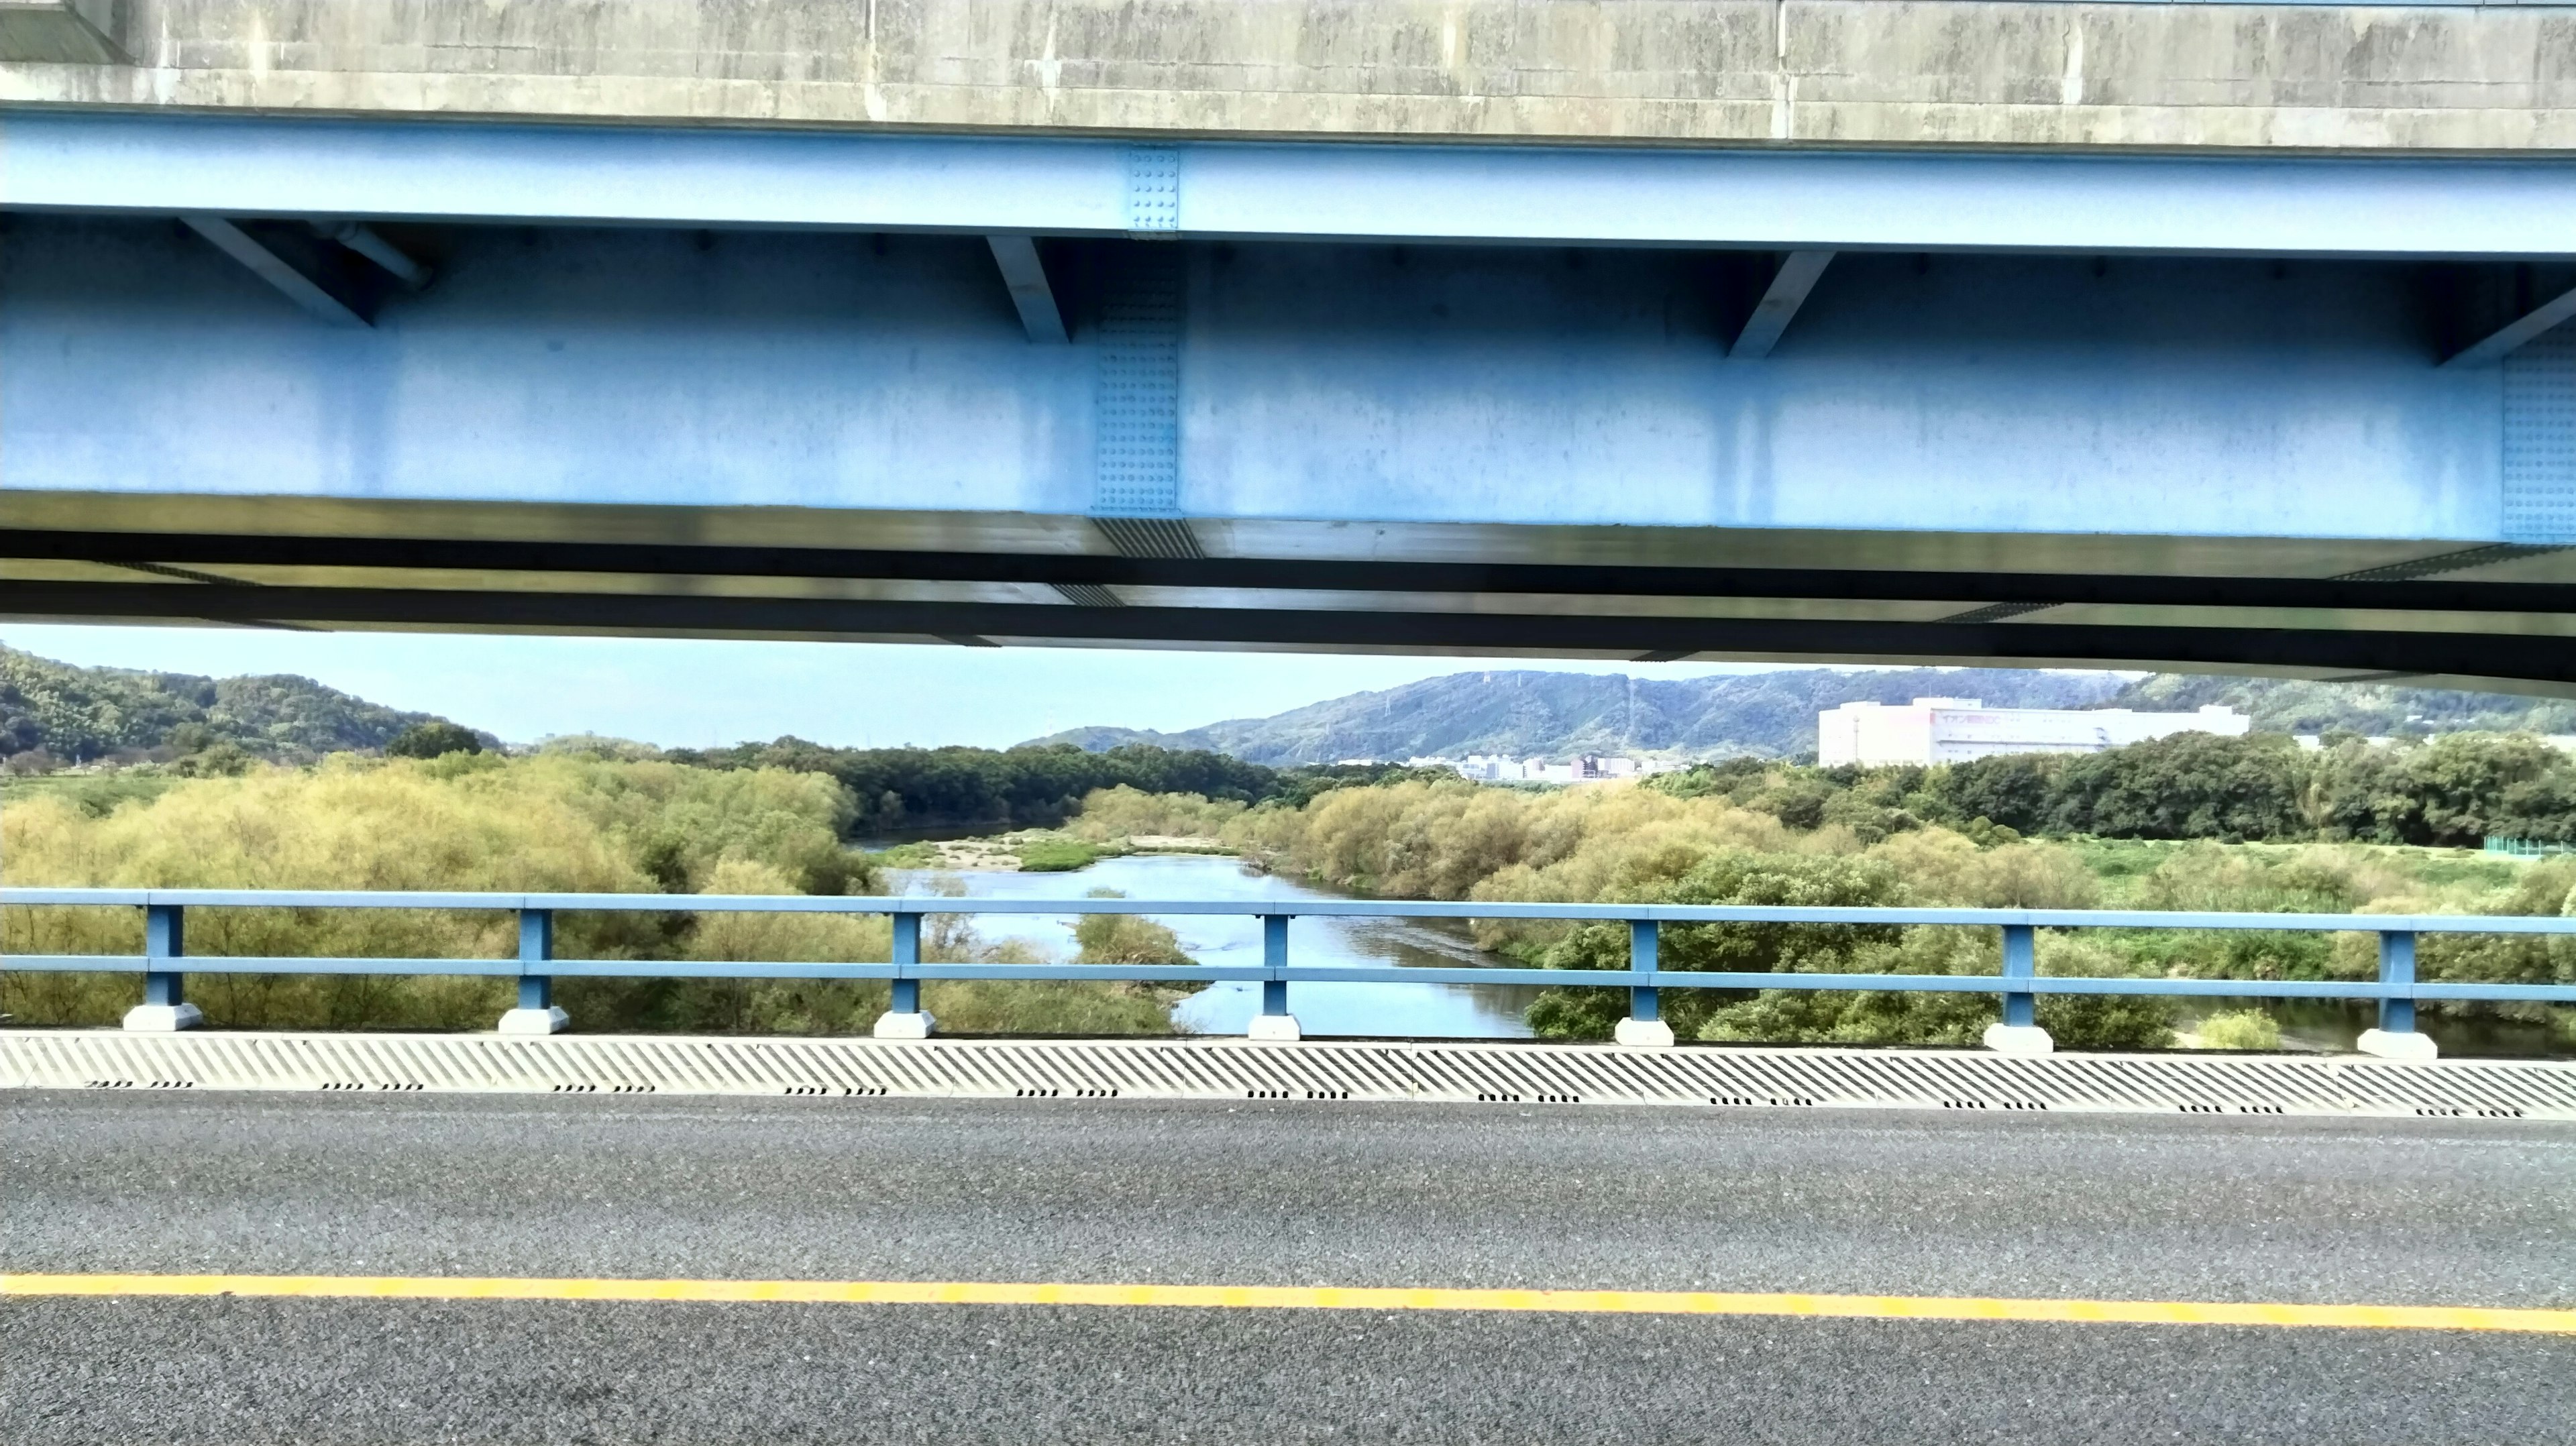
[1097,768,2576,1046]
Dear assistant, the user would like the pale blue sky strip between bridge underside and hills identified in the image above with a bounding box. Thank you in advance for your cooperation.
[0,624,1834,748]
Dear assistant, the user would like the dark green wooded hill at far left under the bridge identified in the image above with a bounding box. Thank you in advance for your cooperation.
[0,636,474,763]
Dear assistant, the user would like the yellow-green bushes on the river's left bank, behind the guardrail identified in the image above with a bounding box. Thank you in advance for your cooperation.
[0,753,1172,1034]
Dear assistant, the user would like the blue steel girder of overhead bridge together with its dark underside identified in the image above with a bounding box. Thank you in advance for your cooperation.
[0,121,2576,691]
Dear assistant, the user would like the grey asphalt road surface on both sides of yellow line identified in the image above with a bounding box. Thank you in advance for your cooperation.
[0,1093,2576,1446]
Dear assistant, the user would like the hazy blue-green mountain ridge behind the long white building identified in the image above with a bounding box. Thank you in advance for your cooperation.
[1033,667,2576,765]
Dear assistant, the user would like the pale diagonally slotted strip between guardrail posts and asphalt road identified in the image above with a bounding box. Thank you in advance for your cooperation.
[0,1028,2576,1121]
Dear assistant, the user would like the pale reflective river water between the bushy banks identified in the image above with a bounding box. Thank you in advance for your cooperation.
[886,853,1538,1039]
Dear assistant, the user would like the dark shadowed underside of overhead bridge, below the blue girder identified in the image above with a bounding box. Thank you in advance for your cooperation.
[0,492,2576,693]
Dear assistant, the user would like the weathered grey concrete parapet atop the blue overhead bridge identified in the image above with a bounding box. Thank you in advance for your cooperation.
[0,0,2576,152]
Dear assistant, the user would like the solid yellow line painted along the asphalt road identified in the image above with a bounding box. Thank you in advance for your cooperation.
[0,1274,2576,1335]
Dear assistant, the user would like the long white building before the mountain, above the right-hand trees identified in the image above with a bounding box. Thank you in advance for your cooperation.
[1816,698,2254,768]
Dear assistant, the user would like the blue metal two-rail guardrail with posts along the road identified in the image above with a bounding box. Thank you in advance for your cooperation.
[0,889,2576,1034]
